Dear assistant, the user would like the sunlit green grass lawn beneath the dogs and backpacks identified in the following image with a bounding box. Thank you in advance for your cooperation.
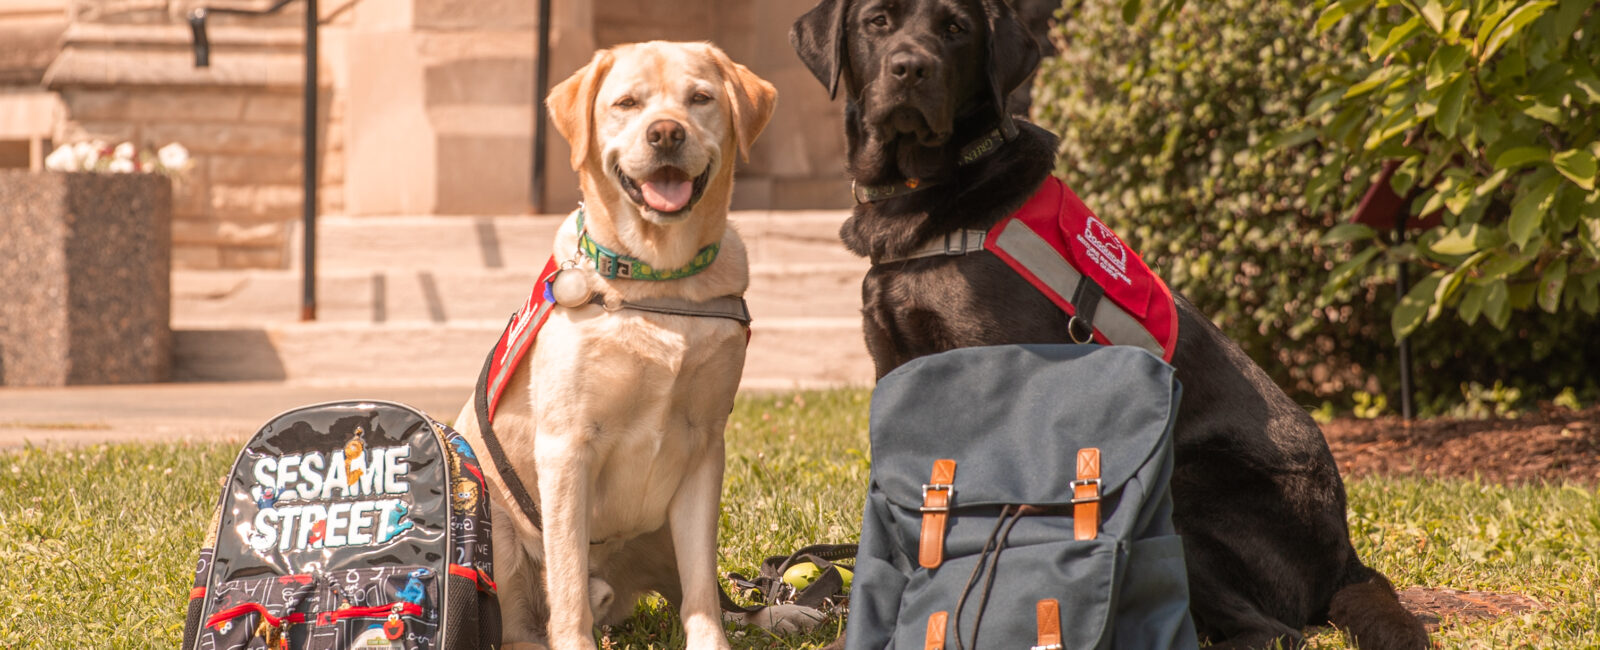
[0,391,1600,648]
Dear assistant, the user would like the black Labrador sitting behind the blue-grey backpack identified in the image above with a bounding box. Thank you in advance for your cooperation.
[790,0,1429,648]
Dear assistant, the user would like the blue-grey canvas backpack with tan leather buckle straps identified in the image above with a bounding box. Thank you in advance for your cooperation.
[845,346,1197,650]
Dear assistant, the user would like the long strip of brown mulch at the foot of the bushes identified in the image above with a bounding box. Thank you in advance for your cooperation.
[1322,405,1600,485]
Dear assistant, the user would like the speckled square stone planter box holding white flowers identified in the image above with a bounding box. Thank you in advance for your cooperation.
[0,171,173,386]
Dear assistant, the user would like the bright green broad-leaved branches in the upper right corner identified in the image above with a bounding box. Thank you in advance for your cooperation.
[1312,0,1600,336]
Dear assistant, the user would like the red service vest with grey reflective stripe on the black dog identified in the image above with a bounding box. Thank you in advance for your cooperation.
[984,176,1178,362]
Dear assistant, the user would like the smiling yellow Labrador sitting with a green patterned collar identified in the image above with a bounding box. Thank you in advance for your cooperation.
[458,42,778,650]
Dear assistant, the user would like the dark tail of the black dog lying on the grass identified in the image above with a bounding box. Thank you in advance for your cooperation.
[1328,565,1429,650]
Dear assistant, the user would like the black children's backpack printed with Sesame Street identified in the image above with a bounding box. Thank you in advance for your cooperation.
[182,402,499,650]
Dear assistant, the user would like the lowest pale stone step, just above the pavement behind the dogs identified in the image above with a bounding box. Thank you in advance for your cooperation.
[174,314,872,391]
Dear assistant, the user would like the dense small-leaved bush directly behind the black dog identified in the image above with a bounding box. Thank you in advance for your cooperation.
[1035,0,1382,394]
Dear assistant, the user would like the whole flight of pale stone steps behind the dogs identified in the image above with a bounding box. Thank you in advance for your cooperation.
[173,211,872,389]
